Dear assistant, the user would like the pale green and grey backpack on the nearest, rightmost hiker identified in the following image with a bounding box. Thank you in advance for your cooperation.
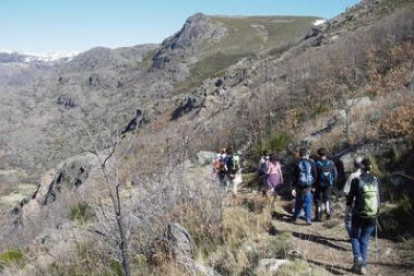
[355,177,379,218]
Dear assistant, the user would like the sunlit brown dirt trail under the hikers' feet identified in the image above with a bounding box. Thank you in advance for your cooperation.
[272,198,414,276]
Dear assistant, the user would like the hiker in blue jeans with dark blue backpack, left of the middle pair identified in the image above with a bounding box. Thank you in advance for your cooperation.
[292,148,317,225]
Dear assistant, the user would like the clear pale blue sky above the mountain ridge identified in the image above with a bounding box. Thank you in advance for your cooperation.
[0,0,359,52]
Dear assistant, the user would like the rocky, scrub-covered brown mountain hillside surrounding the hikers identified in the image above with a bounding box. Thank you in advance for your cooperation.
[0,0,414,276]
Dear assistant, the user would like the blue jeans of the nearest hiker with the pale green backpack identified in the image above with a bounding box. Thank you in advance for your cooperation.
[351,216,375,264]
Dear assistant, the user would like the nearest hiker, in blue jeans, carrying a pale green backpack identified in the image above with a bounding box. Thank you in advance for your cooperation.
[345,158,380,275]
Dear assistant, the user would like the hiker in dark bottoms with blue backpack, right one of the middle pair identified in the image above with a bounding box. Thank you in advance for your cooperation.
[315,148,338,221]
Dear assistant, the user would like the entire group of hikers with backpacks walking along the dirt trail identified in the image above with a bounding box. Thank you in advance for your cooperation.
[213,148,380,275]
